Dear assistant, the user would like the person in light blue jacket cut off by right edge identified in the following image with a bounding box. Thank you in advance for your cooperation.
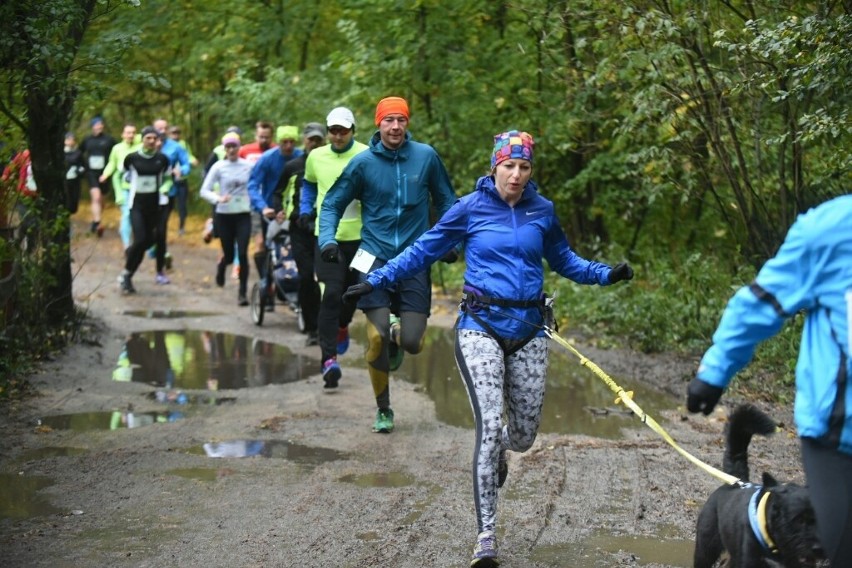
[686,194,852,566]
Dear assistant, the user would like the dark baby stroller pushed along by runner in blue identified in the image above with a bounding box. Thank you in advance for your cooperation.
[250,220,305,331]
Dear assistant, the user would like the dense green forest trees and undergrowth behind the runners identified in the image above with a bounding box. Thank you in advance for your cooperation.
[0,0,852,400]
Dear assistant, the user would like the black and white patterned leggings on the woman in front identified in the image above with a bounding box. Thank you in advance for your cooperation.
[455,329,548,532]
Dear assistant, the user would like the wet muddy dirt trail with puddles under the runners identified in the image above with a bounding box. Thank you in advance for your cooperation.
[0,213,802,568]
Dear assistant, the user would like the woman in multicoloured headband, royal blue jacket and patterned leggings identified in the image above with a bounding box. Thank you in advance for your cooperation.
[344,130,633,567]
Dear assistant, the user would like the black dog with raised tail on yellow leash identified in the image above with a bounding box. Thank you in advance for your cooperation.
[694,405,823,568]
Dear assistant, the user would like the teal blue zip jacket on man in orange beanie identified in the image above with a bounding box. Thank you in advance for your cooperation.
[319,131,456,260]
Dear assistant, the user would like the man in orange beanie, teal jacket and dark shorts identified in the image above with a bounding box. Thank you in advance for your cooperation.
[318,97,456,434]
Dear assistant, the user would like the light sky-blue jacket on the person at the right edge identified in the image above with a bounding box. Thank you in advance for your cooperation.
[697,195,852,453]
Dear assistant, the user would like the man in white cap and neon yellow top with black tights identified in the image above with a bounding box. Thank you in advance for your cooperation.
[299,107,367,389]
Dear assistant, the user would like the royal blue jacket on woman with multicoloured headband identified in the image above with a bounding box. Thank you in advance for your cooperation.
[367,176,611,340]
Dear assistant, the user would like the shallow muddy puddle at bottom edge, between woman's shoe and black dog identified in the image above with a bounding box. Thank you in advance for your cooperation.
[530,533,695,568]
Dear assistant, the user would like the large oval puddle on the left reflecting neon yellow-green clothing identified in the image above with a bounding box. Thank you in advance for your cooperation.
[112,329,319,391]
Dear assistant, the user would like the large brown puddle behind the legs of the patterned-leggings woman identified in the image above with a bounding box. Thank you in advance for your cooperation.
[346,323,678,439]
